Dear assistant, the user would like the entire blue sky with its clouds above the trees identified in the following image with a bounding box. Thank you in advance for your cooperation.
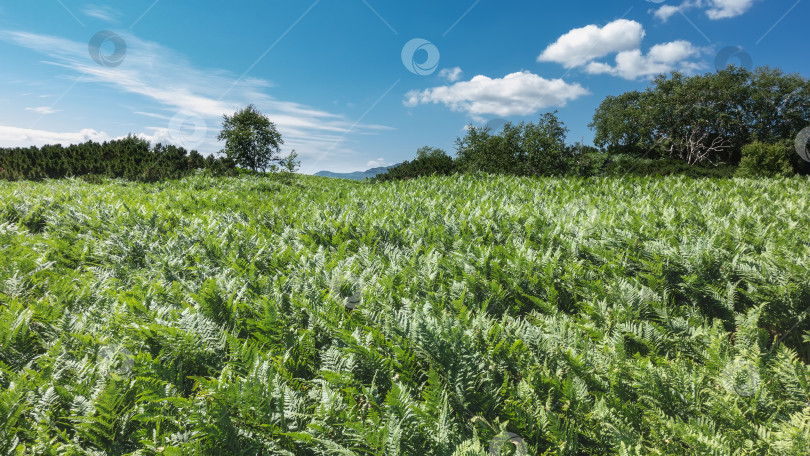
[0,0,810,173]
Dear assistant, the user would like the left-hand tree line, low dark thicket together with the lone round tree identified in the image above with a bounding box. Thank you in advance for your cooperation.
[0,105,300,182]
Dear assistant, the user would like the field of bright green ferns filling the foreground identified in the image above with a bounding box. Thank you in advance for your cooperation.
[0,174,810,455]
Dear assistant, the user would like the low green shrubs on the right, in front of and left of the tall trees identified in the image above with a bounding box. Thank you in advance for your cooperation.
[373,113,810,182]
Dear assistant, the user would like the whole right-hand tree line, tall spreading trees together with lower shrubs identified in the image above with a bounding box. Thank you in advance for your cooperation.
[375,66,810,181]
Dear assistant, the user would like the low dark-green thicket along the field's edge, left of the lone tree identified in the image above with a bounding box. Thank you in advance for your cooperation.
[0,136,235,182]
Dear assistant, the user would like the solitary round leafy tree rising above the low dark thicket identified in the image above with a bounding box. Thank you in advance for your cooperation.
[217,104,284,171]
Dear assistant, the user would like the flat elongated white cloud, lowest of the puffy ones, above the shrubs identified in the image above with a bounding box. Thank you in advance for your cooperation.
[404,71,589,119]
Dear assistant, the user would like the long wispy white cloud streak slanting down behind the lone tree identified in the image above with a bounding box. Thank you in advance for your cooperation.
[0,30,392,171]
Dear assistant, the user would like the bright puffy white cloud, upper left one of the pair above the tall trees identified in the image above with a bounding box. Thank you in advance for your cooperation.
[537,19,644,68]
